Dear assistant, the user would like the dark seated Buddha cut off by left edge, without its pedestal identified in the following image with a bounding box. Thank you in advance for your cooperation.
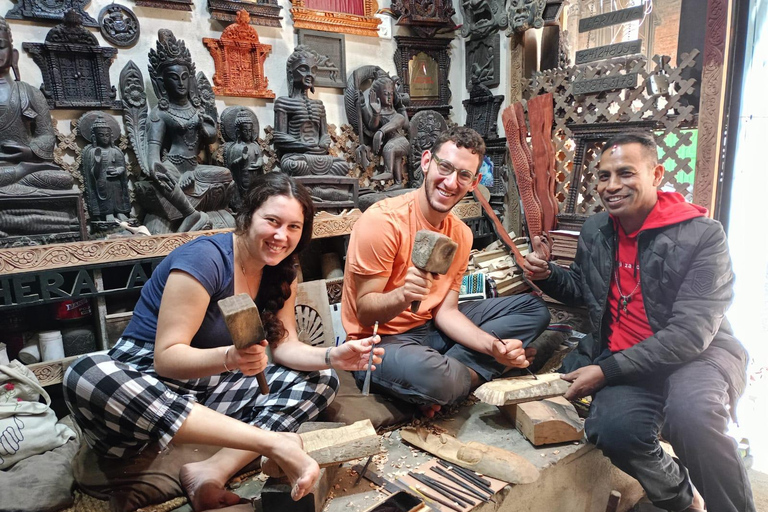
[0,17,75,196]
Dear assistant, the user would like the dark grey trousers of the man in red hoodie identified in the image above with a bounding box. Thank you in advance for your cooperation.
[585,361,755,512]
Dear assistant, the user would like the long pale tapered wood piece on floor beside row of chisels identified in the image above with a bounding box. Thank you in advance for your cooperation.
[400,427,539,484]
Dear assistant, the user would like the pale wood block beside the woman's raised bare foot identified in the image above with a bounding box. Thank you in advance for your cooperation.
[262,419,381,477]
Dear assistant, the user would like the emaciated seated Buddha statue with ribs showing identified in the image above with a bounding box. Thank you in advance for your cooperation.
[273,45,349,200]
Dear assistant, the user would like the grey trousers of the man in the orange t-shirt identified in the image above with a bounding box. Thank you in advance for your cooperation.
[353,295,550,405]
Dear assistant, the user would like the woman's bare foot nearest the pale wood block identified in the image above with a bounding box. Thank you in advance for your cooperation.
[261,432,320,501]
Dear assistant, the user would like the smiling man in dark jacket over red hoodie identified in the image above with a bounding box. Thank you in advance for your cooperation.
[525,134,755,512]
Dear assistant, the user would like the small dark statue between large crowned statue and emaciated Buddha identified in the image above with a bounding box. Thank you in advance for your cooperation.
[221,107,264,210]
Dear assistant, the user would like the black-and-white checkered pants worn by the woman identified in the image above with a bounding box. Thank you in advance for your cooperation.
[63,338,339,457]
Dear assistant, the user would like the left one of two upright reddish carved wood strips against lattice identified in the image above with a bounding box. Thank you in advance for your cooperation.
[501,102,542,238]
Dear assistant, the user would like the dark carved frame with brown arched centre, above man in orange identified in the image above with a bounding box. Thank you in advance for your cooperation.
[394,36,452,118]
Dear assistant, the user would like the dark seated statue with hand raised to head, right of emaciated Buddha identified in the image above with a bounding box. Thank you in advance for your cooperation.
[359,75,410,185]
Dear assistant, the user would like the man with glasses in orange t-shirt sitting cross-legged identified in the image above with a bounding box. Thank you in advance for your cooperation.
[341,127,550,416]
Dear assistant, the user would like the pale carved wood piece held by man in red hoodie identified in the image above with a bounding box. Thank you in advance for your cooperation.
[475,373,571,405]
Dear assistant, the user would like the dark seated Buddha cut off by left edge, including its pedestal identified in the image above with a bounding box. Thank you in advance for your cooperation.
[0,17,79,237]
